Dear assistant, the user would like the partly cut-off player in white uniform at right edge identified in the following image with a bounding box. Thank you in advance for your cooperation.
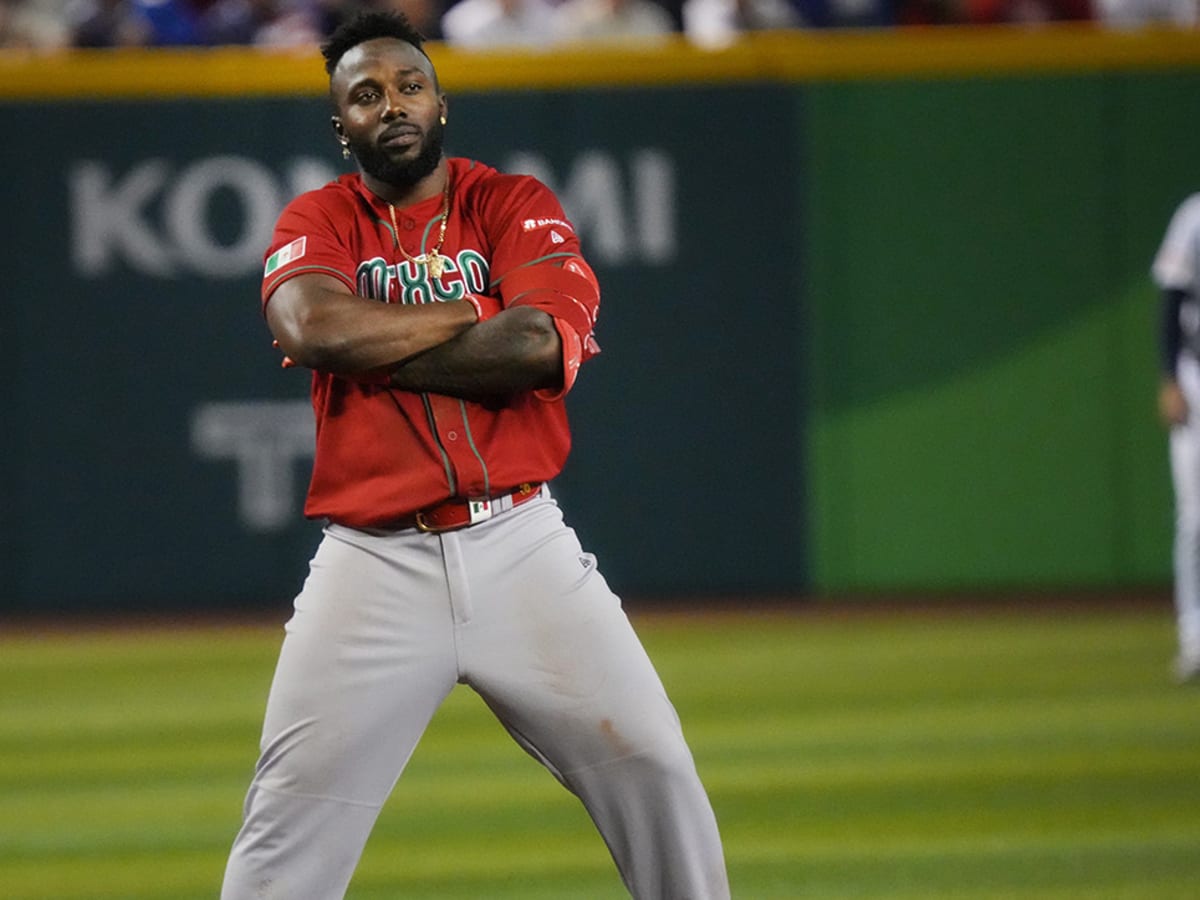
[1151,193,1200,682]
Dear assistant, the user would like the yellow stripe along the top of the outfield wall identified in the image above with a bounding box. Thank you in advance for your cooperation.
[0,24,1200,100]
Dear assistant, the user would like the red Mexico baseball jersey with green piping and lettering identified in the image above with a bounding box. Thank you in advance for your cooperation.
[263,158,600,527]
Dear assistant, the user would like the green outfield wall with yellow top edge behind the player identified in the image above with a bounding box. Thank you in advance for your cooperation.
[0,29,1200,611]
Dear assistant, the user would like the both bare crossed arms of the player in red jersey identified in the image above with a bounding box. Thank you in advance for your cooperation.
[266,274,563,401]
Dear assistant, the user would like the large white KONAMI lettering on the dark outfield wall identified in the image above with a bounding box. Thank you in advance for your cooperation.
[67,148,678,278]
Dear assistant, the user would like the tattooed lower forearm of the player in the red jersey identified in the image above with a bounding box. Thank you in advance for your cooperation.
[391,307,563,401]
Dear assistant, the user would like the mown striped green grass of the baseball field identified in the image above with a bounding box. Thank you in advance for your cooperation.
[0,604,1200,900]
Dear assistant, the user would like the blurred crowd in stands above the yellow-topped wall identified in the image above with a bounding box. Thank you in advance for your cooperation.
[0,0,1200,52]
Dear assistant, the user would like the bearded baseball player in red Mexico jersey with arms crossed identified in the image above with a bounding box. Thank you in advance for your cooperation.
[222,12,730,900]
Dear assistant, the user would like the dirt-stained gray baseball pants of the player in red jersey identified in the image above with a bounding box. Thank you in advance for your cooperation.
[221,492,730,900]
